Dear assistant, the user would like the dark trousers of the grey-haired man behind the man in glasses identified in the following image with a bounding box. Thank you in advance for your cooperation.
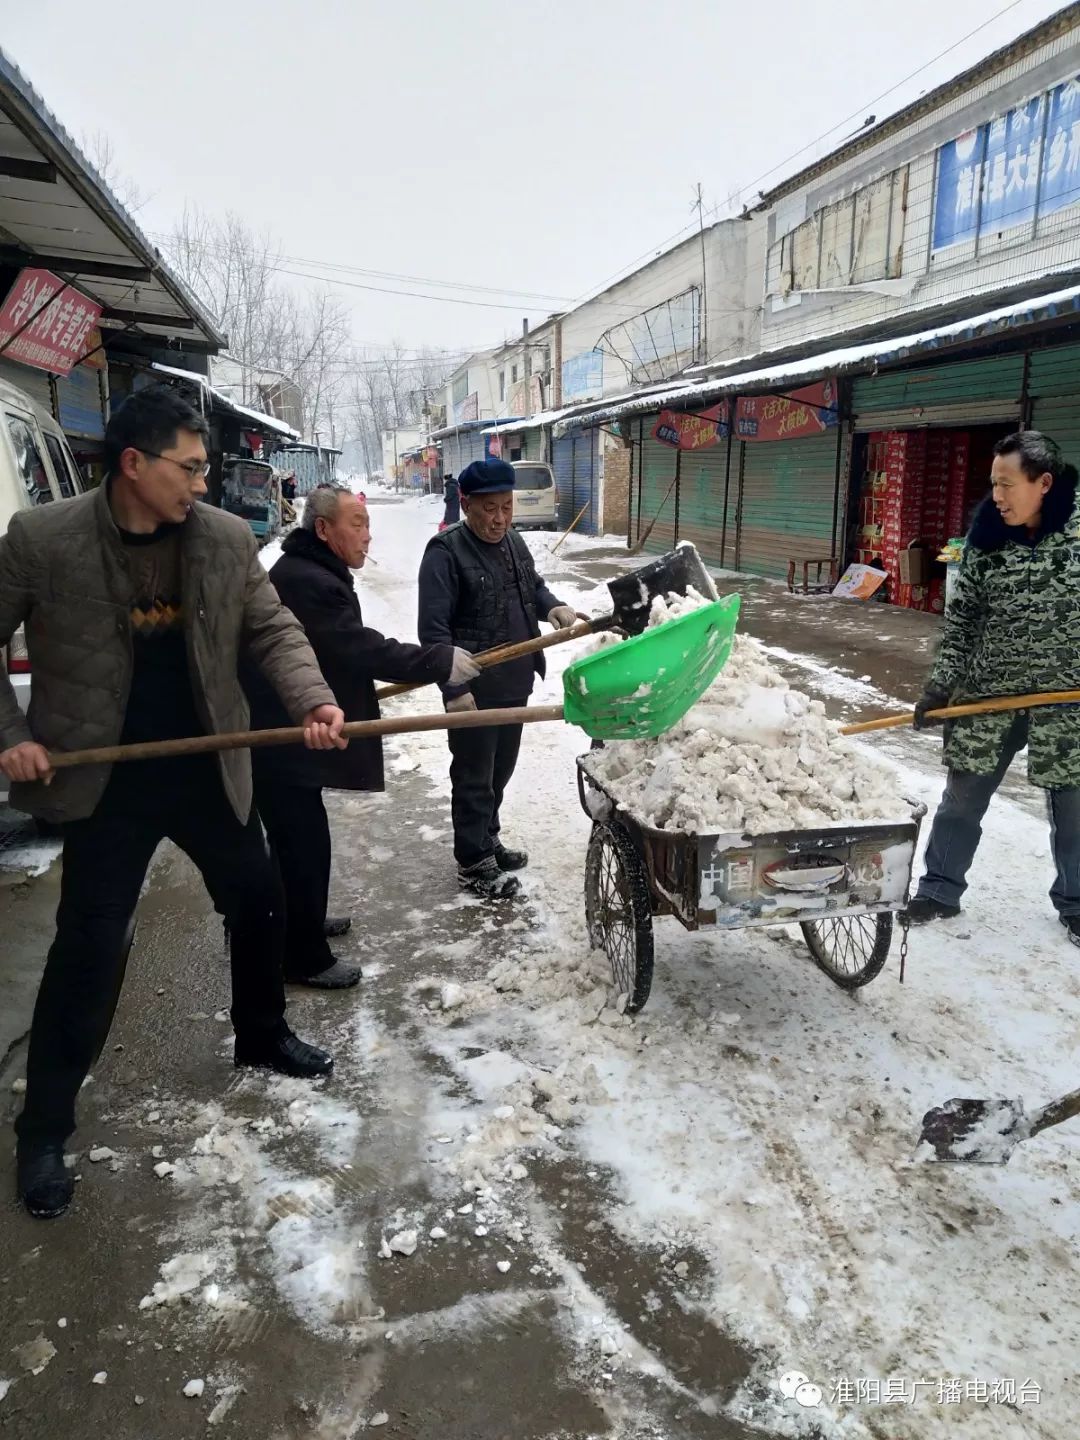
[255,765,334,979]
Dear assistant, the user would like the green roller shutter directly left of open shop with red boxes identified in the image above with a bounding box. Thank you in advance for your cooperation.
[732,431,837,579]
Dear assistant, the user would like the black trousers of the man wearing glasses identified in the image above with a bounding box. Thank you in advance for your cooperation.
[16,760,285,1140]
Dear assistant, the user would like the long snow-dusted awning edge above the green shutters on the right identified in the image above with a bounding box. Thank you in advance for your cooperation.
[556,285,1080,433]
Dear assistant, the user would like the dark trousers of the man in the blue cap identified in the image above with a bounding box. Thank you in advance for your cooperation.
[448,700,527,867]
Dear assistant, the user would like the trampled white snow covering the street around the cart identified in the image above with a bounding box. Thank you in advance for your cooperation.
[139,497,1080,1440]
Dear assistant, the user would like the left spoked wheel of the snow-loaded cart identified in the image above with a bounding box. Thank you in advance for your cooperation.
[585,822,652,1014]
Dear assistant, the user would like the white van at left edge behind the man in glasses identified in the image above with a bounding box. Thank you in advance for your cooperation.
[0,379,84,804]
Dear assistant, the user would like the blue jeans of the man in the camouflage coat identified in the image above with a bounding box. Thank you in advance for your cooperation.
[919,716,1080,916]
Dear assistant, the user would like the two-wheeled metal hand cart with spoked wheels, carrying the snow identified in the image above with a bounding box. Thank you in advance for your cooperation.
[577,756,926,1012]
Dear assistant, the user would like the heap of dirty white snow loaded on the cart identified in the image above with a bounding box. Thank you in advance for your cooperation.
[586,592,907,835]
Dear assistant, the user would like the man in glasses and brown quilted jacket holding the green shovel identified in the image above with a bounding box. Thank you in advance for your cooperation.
[0,386,346,1218]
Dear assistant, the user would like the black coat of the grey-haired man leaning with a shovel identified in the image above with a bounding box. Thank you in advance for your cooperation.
[245,530,454,791]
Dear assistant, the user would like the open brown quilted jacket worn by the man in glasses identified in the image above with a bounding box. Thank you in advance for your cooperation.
[0,487,334,824]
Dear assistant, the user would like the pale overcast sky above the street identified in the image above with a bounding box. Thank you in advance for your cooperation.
[1,0,1058,360]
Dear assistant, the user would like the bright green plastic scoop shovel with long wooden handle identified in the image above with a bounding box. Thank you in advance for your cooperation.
[38,595,739,770]
